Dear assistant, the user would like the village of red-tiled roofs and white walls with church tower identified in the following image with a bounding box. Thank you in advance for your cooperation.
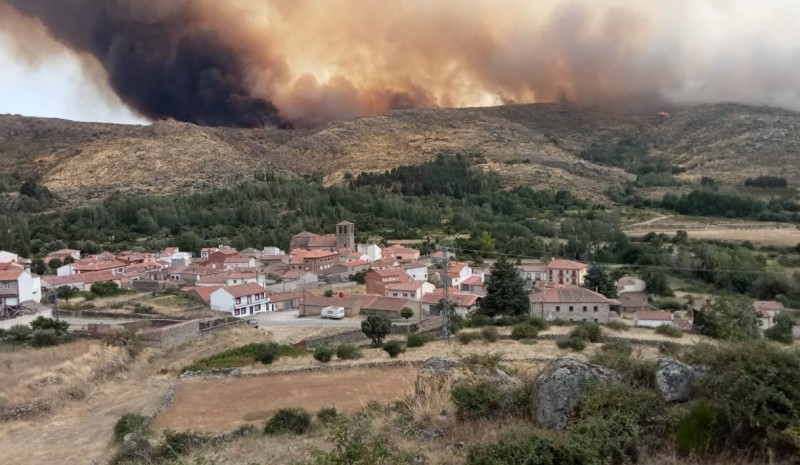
[0,221,800,338]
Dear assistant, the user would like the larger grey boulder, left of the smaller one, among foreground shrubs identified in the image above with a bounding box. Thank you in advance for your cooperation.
[532,358,621,429]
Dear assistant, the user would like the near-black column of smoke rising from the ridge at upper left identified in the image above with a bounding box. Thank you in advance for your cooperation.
[4,0,281,127]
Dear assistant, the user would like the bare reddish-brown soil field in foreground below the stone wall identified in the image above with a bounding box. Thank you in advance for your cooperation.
[155,367,417,432]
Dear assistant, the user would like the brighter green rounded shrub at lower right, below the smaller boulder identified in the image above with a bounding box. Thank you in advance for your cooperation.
[675,400,721,456]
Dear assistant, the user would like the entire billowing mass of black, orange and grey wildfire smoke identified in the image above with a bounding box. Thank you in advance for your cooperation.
[0,0,800,127]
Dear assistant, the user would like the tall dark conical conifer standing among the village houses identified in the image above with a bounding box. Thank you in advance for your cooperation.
[478,257,530,316]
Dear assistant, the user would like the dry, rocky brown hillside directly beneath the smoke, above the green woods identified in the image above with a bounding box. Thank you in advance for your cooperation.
[0,104,800,201]
